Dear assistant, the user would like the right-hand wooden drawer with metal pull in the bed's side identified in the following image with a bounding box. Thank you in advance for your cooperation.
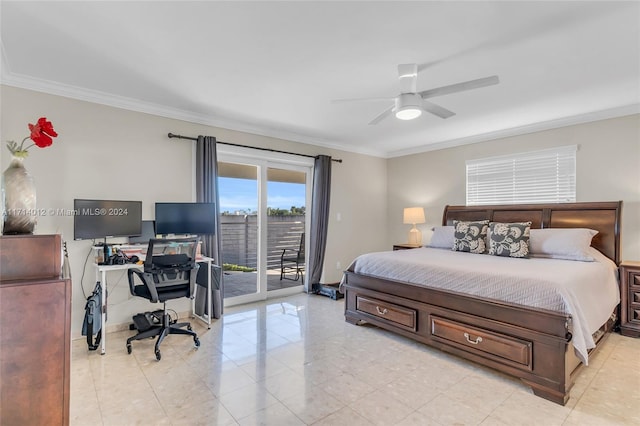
[431,315,532,370]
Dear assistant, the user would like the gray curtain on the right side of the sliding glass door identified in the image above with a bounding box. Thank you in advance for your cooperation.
[309,155,331,293]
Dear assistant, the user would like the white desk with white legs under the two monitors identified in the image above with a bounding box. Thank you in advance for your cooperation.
[94,250,213,355]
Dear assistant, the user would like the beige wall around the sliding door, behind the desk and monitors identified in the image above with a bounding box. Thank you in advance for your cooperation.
[0,85,387,336]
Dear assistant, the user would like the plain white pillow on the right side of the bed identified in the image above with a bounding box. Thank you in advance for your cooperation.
[529,228,598,262]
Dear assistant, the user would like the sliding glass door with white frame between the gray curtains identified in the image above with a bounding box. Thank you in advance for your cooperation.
[218,149,312,306]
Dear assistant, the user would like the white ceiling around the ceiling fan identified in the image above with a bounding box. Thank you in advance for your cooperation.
[0,1,640,157]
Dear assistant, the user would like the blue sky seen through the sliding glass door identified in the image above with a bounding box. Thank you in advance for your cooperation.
[218,177,305,213]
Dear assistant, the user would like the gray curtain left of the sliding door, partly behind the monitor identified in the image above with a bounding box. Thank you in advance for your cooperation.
[196,136,224,318]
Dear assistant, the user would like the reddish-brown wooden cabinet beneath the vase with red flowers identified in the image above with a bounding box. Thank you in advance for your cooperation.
[0,235,71,425]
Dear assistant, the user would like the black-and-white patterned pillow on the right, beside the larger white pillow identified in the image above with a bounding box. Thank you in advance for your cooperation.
[488,222,531,257]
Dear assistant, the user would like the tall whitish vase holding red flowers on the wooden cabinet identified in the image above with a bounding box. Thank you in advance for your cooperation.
[2,156,37,235]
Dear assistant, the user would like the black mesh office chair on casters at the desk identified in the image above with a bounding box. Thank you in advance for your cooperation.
[127,238,200,361]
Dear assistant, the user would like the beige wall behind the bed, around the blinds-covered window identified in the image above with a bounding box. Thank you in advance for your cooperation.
[387,115,640,260]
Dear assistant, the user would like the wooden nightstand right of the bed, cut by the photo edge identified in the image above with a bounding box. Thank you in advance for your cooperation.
[620,261,640,337]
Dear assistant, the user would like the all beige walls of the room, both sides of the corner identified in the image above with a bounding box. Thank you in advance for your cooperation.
[0,86,640,336]
